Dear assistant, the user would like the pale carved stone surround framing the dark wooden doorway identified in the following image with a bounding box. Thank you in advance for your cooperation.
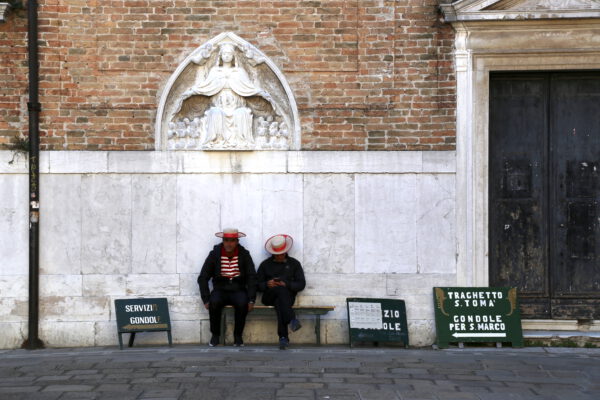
[440,0,600,331]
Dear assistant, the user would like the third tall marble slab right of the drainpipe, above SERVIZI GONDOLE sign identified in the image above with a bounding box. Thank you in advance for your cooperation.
[131,174,177,274]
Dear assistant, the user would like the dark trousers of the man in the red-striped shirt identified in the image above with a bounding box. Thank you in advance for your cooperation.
[208,289,248,336]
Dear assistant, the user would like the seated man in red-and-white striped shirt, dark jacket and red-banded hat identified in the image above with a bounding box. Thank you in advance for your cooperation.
[198,229,256,347]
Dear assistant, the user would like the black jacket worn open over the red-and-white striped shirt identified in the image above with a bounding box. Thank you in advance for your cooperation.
[198,243,256,304]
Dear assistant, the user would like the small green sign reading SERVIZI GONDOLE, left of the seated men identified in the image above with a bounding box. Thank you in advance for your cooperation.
[115,298,172,350]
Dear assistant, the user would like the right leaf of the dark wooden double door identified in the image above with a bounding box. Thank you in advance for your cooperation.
[550,74,600,310]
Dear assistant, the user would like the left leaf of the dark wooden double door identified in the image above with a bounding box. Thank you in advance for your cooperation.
[489,76,550,318]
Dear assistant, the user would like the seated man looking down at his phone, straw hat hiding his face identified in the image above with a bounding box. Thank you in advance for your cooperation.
[258,235,306,350]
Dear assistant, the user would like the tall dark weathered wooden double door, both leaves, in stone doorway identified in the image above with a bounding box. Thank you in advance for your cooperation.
[489,72,600,319]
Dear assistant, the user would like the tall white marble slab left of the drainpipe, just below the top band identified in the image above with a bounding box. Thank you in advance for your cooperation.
[0,174,29,275]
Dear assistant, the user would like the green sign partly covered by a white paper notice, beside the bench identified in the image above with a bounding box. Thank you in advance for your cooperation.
[346,298,408,347]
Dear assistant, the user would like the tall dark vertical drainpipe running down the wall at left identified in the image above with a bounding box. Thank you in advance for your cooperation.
[21,0,44,350]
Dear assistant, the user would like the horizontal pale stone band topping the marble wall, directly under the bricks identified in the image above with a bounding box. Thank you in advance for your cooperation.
[0,150,456,174]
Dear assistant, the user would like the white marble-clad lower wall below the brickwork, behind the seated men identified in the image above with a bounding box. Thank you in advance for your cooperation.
[0,151,464,348]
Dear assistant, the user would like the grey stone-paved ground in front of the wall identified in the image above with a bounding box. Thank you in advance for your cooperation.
[0,345,600,400]
